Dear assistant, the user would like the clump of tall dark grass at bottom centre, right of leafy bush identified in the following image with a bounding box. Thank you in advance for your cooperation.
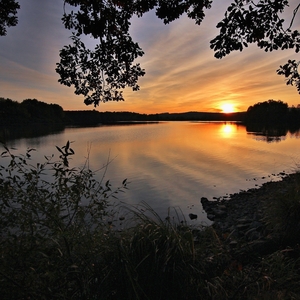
[99,203,201,299]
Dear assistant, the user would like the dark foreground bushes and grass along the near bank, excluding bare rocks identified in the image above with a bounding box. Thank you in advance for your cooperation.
[0,143,300,300]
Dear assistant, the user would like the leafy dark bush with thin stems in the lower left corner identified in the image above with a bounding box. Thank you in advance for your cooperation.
[0,142,126,299]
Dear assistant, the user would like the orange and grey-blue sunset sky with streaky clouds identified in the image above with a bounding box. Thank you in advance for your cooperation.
[0,0,300,114]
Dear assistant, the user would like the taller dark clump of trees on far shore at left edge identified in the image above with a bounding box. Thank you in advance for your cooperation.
[0,98,65,126]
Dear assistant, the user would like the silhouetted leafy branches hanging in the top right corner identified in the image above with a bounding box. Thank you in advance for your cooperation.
[210,0,300,93]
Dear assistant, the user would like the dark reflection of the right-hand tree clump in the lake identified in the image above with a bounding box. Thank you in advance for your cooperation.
[246,124,300,143]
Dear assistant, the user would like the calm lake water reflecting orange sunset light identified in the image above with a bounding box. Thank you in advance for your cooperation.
[2,122,300,224]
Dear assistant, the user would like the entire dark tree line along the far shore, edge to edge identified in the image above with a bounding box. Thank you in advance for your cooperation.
[0,98,300,128]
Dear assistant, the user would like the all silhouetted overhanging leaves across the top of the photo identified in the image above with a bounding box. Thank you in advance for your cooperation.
[0,0,300,106]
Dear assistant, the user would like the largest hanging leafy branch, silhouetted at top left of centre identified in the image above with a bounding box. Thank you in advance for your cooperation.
[56,0,212,106]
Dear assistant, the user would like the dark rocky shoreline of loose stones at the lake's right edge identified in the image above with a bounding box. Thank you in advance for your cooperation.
[201,172,299,241]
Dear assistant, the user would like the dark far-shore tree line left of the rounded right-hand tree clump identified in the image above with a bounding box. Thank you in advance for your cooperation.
[0,98,245,127]
